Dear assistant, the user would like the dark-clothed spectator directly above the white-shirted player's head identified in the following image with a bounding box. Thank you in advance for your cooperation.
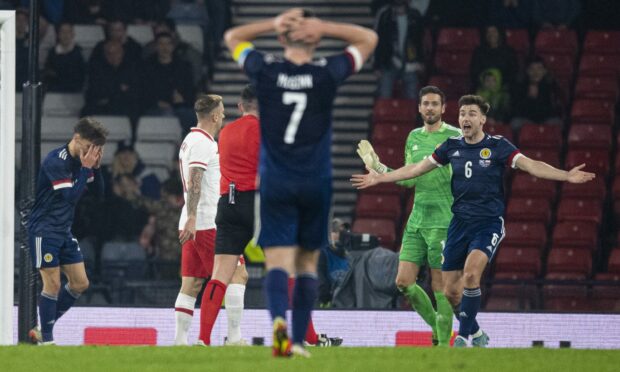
[142,33,196,132]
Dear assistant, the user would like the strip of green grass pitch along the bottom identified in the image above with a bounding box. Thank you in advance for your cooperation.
[0,345,620,372]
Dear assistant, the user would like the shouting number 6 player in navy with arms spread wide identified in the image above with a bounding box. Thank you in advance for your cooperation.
[351,95,595,347]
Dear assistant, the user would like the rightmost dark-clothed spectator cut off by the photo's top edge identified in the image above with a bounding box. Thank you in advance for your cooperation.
[534,0,581,29]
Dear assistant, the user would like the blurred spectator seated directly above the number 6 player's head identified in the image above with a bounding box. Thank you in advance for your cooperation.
[476,68,510,124]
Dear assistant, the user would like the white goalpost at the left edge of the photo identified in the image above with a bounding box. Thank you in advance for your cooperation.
[0,11,15,345]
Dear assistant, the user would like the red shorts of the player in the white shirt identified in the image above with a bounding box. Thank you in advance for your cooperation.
[181,229,215,278]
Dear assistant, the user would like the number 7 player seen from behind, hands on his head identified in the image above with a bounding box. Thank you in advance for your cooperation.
[225,9,377,357]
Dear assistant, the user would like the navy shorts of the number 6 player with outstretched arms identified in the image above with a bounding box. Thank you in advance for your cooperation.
[441,216,506,271]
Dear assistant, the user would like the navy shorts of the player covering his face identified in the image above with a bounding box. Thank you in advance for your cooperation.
[28,233,84,269]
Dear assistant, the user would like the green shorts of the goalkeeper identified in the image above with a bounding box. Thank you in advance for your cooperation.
[398,225,448,269]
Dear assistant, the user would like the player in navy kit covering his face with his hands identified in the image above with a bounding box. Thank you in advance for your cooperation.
[28,118,108,345]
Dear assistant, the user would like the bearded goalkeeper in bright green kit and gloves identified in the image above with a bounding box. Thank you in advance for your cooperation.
[357,86,461,346]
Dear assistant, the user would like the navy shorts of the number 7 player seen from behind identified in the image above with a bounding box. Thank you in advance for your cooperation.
[258,175,332,250]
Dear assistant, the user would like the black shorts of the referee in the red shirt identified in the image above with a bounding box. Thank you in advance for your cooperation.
[215,191,255,255]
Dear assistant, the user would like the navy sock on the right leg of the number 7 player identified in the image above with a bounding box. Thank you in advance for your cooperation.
[293,273,318,345]
